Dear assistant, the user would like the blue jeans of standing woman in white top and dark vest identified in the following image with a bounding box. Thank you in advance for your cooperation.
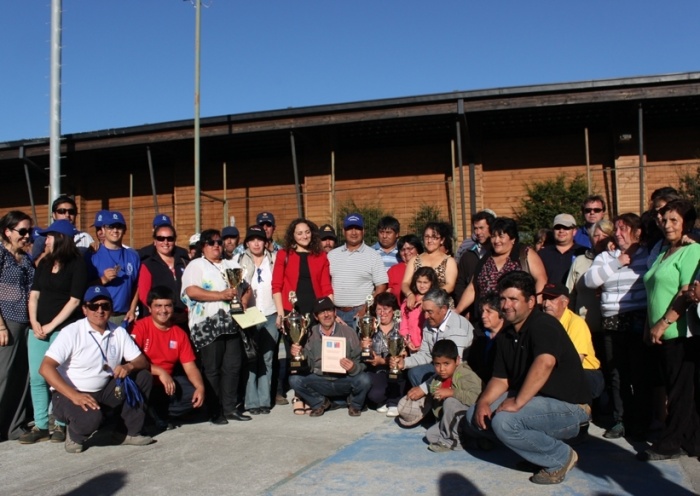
[245,312,279,409]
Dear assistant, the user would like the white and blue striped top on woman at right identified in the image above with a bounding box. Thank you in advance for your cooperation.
[583,247,649,317]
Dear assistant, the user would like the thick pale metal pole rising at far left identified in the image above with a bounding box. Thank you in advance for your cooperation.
[49,0,62,204]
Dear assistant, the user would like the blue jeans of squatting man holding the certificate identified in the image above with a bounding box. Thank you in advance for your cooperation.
[289,372,372,410]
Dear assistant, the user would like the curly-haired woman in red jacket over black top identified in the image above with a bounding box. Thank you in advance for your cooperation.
[272,219,333,322]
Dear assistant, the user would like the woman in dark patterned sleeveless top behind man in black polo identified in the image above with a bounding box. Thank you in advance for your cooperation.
[455,217,547,313]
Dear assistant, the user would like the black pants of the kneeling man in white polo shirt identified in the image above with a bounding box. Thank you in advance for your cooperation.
[53,370,153,444]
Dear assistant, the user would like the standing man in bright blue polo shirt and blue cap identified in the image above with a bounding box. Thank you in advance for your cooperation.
[87,212,141,324]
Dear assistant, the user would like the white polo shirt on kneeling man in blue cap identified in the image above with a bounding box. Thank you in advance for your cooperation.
[46,318,141,393]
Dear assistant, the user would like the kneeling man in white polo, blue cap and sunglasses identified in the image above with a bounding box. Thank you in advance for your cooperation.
[39,286,153,453]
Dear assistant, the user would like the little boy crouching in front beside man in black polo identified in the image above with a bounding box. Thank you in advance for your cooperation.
[406,339,482,453]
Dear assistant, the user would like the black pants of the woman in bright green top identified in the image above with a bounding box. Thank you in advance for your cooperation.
[652,337,700,456]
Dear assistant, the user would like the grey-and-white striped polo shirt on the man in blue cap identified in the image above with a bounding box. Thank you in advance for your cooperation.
[328,243,389,307]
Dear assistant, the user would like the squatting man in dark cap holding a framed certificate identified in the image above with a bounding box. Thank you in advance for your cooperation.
[289,297,372,417]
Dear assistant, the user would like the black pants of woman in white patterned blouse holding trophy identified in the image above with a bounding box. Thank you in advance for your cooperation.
[200,334,243,416]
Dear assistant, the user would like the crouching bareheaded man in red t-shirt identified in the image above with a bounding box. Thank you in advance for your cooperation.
[131,286,204,429]
